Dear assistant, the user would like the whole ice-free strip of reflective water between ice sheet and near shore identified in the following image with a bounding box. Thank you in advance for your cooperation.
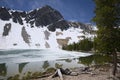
[0,54,110,78]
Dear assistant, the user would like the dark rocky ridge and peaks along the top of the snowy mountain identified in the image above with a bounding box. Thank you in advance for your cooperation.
[0,5,94,31]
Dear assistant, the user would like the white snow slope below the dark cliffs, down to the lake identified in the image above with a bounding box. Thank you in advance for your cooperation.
[0,19,93,49]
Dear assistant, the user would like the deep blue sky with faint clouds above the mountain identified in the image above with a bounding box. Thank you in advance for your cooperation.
[0,0,95,23]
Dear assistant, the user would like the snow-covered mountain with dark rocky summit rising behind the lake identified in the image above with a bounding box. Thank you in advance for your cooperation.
[0,5,94,49]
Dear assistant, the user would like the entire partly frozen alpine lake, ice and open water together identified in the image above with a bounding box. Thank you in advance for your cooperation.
[0,49,110,80]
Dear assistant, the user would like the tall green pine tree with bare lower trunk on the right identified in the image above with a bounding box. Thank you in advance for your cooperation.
[93,0,120,76]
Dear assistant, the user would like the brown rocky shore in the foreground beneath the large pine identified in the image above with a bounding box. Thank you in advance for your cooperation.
[32,66,120,80]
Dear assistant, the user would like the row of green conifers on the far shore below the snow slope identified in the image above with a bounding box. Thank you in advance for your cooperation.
[62,39,93,51]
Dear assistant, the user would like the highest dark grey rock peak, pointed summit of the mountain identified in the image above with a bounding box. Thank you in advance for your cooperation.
[25,5,63,27]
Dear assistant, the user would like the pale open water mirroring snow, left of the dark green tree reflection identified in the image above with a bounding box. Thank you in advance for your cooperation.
[0,59,84,80]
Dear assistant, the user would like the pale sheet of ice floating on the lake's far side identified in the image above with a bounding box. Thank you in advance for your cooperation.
[0,49,90,63]
